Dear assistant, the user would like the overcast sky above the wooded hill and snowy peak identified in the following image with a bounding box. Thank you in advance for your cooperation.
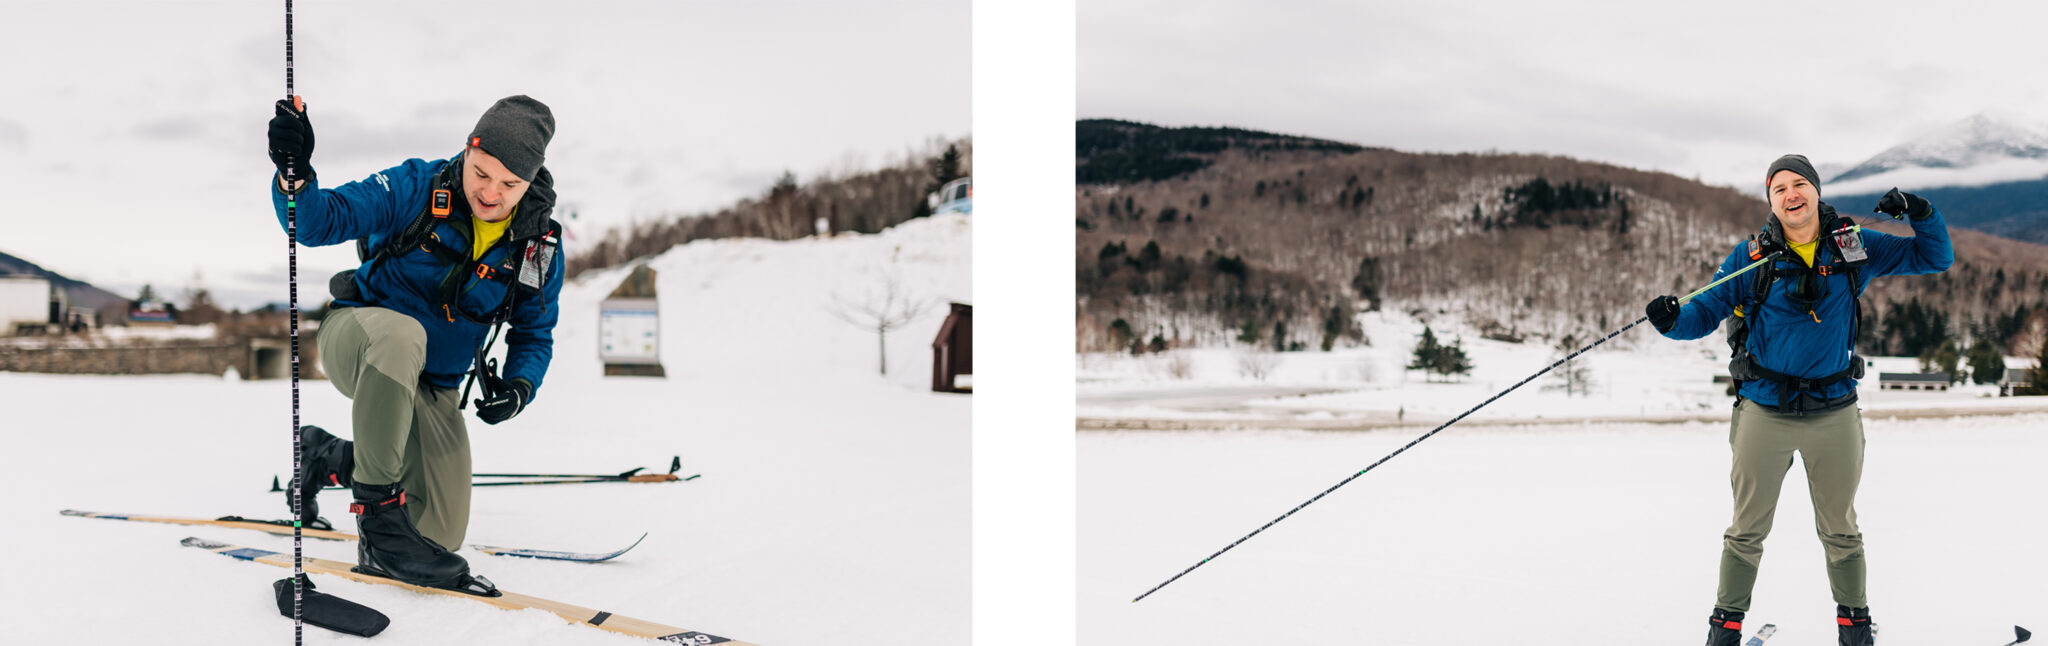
[1077,0,2048,197]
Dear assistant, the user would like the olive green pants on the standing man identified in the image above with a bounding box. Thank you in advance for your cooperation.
[1714,400,1870,611]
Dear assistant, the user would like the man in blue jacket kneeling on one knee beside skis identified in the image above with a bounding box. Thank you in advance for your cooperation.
[270,96,563,595]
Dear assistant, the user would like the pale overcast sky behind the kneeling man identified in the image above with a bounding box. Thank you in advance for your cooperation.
[0,0,971,308]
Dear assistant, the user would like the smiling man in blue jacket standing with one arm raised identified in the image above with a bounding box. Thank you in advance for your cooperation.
[1647,154,1956,646]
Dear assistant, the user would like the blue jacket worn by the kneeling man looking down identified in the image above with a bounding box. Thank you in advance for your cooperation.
[270,156,563,404]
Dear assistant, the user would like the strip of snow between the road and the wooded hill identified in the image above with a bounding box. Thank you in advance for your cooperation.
[1075,312,2048,429]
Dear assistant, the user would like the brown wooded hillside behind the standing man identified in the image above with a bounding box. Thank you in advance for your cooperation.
[1075,119,2048,355]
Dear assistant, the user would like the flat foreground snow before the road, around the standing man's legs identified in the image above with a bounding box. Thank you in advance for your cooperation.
[1077,414,2048,646]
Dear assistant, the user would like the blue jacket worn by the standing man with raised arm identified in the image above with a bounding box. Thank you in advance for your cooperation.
[1663,209,1956,406]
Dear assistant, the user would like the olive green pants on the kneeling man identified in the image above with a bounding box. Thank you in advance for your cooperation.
[319,308,469,552]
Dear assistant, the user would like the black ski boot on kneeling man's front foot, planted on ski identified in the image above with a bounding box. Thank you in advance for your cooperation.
[348,482,498,597]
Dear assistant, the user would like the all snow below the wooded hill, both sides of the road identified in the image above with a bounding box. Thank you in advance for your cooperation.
[1077,305,2048,646]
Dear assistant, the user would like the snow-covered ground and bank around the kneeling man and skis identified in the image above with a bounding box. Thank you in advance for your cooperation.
[0,215,971,646]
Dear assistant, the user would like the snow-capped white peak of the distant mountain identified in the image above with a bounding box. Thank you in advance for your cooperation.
[1823,113,2048,195]
